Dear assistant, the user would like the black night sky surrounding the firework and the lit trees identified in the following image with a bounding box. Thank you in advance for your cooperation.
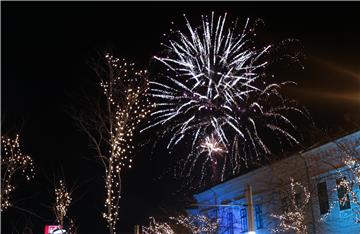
[1,2,360,233]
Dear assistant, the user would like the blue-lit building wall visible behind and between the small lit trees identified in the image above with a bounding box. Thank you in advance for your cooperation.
[189,131,360,234]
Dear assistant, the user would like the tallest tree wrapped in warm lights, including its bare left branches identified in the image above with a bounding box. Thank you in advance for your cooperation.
[75,54,150,233]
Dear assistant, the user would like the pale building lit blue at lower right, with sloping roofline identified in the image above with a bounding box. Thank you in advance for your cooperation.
[188,131,360,234]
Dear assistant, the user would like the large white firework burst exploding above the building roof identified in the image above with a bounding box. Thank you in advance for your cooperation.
[143,13,305,182]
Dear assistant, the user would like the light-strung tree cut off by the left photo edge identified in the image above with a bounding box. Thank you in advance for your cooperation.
[1,134,34,211]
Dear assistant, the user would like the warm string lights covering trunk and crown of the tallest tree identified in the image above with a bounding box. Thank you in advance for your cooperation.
[101,54,149,232]
